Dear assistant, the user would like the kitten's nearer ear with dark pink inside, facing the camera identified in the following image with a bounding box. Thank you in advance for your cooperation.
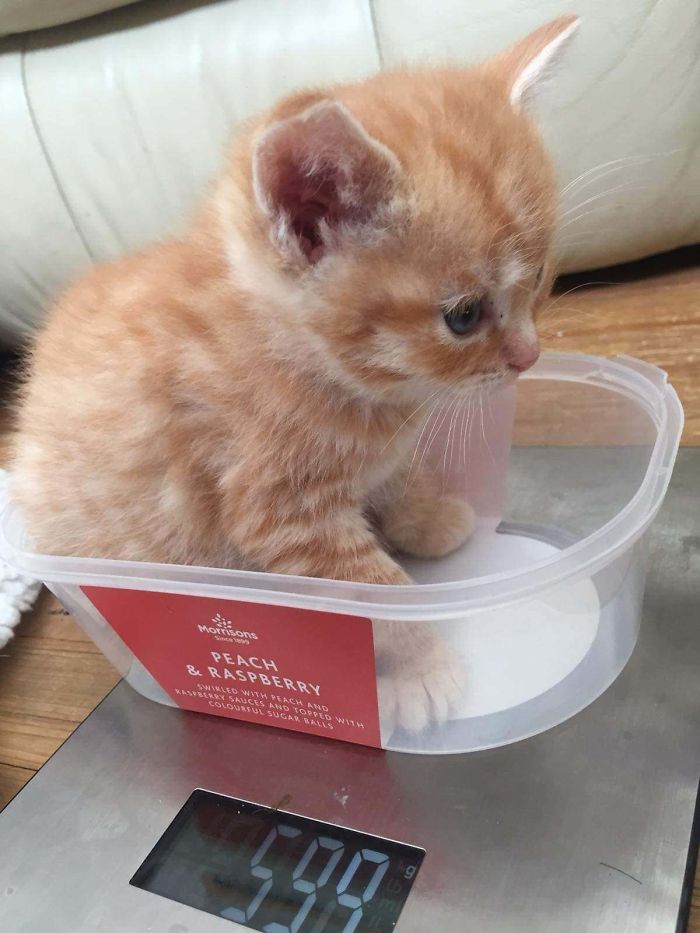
[253,100,401,264]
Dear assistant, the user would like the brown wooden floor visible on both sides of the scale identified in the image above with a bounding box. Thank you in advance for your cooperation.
[0,248,700,933]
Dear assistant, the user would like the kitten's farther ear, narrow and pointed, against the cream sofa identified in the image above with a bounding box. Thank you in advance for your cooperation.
[491,16,581,111]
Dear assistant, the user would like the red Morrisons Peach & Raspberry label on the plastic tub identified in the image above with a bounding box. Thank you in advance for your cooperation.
[83,587,381,748]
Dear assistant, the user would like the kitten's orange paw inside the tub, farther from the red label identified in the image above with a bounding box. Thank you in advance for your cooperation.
[383,496,475,558]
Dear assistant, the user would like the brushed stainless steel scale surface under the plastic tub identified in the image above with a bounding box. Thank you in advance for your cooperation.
[0,451,700,933]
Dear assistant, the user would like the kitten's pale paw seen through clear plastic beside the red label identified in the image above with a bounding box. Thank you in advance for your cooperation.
[377,623,464,740]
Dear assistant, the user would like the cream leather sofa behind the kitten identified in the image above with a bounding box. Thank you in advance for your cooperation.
[0,0,700,343]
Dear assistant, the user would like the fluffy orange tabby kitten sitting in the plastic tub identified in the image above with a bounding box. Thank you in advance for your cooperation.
[12,12,575,728]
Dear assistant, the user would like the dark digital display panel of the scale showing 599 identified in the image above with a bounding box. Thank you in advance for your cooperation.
[131,790,425,933]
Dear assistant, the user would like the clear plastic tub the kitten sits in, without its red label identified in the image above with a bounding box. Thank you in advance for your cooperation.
[0,354,683,753]
